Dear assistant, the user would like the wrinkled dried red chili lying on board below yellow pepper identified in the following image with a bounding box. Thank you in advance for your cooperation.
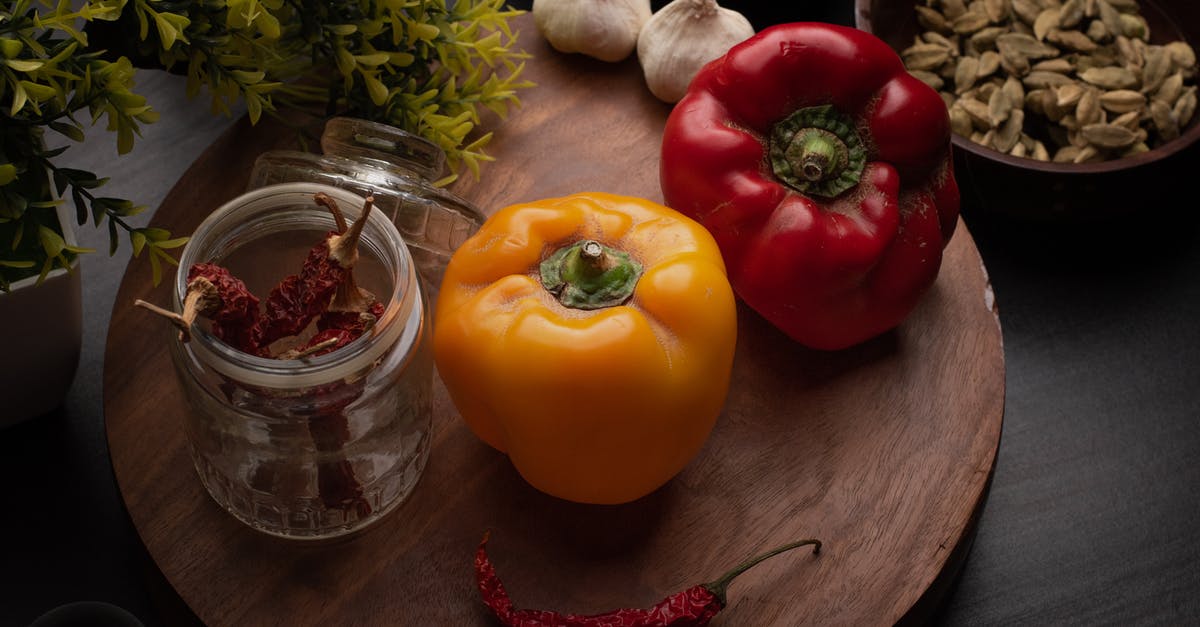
[475,533,821,627]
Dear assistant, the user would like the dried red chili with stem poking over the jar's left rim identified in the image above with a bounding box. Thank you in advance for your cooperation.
[134,258,262,354]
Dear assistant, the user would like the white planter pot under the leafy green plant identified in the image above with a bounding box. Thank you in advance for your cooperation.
[0,203,83,428]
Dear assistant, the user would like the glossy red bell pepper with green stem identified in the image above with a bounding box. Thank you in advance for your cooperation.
[660,23,959,350]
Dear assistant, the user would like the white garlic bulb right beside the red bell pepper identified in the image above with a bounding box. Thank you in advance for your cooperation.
[637,0,754,102]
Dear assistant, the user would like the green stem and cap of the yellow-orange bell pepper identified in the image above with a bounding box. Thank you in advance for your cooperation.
[539,239,642,310]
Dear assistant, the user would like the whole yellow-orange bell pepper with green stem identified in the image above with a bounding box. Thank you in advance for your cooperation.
[433,193,737,503]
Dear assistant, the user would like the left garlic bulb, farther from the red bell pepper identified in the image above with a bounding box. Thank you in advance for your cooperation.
[533,0,650,61]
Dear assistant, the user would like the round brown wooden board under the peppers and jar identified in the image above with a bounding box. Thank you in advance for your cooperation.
[104,16,1004,626]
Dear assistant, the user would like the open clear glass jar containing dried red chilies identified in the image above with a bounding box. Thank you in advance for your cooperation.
[172,183,433,539]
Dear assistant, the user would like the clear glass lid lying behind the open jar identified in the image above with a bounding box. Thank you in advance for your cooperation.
[250,118,484,291]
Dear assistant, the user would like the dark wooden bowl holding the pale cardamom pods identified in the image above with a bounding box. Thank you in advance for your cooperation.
[854,0,1200,221]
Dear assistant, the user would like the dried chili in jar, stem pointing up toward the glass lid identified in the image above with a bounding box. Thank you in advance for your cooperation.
[258,195,374,347]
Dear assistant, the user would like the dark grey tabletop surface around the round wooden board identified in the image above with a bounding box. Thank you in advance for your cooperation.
[0,0,1200,626]
